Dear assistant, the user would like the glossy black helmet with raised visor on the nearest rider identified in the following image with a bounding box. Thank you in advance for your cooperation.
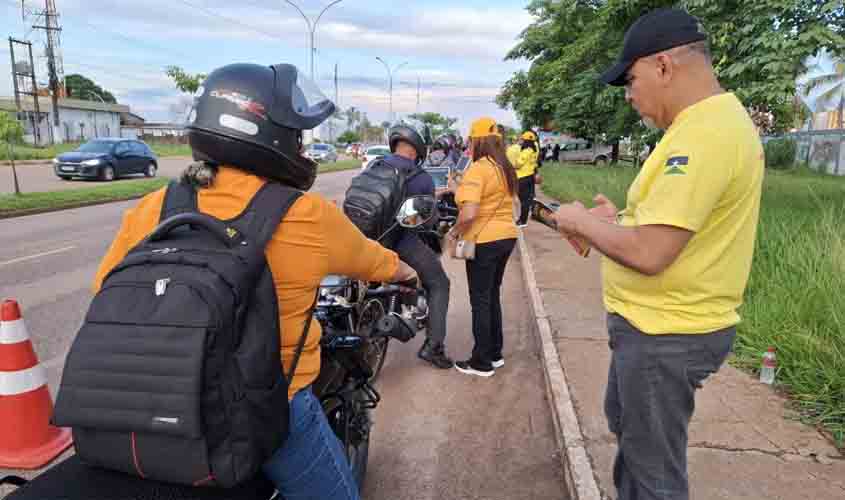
[186,63,335,190]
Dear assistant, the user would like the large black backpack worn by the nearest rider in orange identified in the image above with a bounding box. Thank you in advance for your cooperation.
[53,181,313,487]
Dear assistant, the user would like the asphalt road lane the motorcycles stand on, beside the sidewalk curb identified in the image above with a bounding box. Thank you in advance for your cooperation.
[0,170,565,500]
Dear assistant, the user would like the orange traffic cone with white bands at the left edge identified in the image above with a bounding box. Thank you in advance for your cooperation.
[0,300,72,469]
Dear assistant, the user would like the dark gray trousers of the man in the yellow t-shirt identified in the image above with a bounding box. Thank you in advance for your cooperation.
[604,314,736,500]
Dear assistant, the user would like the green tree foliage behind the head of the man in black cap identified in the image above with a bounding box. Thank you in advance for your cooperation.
[496,0,845,142]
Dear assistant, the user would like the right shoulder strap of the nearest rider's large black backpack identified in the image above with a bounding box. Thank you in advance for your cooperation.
[244,182,319,382]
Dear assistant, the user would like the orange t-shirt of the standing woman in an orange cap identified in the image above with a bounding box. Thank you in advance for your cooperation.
[455,158,517,243]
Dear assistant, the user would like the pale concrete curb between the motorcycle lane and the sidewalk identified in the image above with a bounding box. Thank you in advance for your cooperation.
[519,231,603,500]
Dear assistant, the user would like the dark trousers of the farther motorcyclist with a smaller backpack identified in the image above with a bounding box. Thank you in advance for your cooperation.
[396,234,451,344]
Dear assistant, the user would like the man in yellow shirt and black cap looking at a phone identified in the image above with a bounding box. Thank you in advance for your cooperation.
[555,9,763,500]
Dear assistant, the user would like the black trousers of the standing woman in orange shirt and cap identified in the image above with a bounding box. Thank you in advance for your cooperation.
[466,239,516,369]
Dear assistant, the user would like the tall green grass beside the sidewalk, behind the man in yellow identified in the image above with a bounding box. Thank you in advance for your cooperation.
[542,161,845,448]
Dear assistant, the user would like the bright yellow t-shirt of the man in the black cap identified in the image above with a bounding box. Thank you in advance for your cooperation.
[602,93,764,334]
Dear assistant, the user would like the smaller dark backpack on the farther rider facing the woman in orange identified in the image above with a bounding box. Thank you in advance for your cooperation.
[343,158,421,248]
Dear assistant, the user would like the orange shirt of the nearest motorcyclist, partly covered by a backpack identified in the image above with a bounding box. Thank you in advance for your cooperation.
[93,167,399,398]
